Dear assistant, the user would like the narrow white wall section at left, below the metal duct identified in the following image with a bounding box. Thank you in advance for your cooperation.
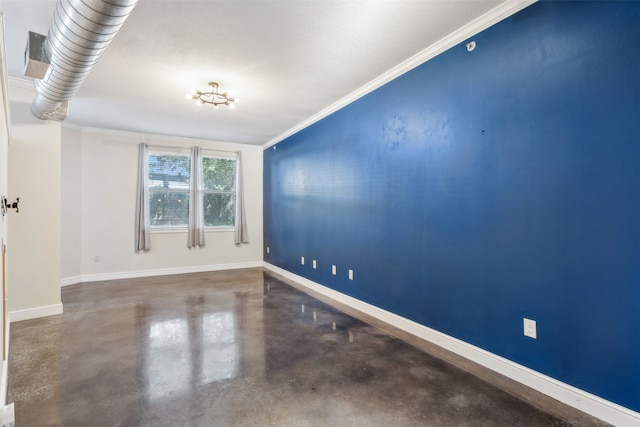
[7,81,62,320]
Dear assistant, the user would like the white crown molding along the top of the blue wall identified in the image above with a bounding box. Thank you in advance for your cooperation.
[262,0,538,149]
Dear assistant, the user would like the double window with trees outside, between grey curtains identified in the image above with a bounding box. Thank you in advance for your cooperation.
[147,150,237,229]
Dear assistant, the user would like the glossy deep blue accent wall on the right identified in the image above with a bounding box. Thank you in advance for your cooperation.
[264,1,640,411]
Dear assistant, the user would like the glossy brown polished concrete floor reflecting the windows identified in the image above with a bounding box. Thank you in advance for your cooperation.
[8,269,605,427]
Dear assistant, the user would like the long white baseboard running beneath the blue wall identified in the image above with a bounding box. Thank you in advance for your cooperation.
[264,262,640,427]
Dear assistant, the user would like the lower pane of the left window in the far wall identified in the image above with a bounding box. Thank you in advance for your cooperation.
[149,190,189,227]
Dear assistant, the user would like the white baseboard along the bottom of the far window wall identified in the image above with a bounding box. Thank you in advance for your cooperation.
[60,261,263,286]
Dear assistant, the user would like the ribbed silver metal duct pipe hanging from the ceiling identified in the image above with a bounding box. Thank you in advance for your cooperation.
[31,0,138,121]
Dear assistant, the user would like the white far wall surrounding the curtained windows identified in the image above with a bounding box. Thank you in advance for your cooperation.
[62,128,262,284]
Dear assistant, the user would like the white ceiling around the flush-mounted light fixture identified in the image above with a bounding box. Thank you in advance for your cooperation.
[0,0,520,145]
